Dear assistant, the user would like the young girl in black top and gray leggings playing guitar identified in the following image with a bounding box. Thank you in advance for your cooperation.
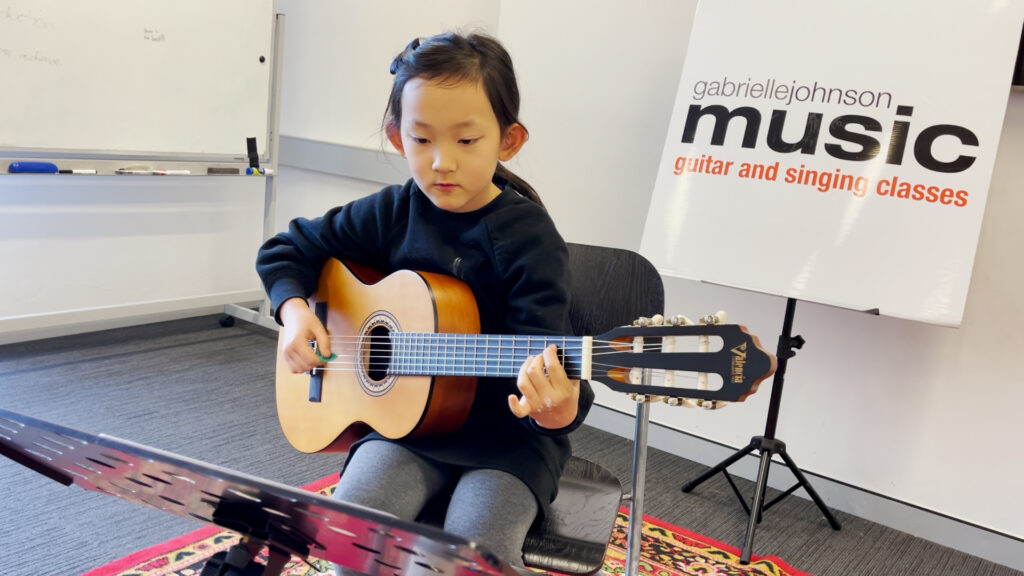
[257,34,594,566]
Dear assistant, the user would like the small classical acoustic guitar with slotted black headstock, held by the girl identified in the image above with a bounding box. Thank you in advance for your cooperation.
[276,258,776,452]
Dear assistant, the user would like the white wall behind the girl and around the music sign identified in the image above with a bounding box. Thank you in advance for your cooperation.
[268,0,1024,556]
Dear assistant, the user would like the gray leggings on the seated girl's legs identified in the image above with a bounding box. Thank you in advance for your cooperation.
[334,441,537,575]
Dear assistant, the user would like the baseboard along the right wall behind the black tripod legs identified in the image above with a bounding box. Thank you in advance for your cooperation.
[587,404,1024,570]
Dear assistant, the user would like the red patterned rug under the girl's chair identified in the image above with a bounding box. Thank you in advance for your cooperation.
[82,477,810,576]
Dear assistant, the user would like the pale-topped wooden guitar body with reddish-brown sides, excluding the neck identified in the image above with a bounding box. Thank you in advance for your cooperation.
[276,258,479,452]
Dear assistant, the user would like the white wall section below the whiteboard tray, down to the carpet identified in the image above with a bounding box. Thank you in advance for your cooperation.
[0,174,265,342]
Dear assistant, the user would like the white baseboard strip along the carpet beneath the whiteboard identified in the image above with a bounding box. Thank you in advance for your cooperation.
[0,290,263,344]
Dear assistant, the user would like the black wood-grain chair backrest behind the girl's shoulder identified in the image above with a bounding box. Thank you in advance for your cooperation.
[567,242,665,336]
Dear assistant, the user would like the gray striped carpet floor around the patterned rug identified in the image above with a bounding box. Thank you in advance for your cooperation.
[0,316,1022,576]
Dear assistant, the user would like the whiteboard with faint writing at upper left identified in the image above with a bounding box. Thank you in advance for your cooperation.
[0,0,274,158]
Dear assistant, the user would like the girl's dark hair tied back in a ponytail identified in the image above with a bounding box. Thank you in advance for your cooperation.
[384,32,544,206]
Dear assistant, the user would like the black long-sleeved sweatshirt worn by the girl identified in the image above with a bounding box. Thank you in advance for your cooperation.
[256,179,594,515]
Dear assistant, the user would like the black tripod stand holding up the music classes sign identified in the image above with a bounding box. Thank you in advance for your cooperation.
[682,298,841,564]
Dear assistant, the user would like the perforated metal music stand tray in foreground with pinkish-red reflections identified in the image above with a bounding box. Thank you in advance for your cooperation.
[0,409,517,576]
